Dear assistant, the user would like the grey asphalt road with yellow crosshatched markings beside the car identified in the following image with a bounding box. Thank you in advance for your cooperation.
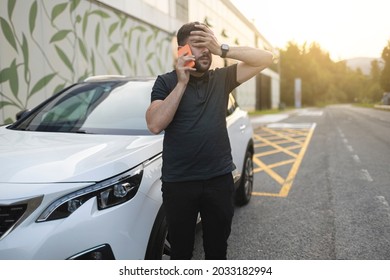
[194,105,390,260]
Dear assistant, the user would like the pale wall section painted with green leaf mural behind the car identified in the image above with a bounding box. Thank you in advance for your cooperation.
[0,0,173,124]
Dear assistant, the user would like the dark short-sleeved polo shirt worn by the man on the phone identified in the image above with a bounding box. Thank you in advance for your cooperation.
[151,64,239,182]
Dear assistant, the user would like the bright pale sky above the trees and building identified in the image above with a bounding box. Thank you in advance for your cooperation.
[231,0,390,61]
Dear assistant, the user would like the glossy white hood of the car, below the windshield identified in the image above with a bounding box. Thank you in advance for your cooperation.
[0,127,162,183]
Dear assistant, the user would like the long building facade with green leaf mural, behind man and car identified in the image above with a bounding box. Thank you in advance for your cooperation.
[0,0,279,125]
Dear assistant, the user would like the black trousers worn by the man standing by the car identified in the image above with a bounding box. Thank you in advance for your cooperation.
[162,173,234,260]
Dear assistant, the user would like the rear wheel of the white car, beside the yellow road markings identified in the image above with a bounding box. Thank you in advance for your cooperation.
[236,151,253,206]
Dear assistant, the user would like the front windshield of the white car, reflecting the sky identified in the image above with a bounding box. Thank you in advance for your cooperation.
[11,81,153,135]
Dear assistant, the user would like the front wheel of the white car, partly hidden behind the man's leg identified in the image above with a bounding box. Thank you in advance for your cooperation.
[145,207,171,260]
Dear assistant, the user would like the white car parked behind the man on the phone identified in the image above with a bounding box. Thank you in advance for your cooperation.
[0,76,253,260]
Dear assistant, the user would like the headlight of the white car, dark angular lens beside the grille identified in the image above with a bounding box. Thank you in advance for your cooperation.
[37,165,143,222]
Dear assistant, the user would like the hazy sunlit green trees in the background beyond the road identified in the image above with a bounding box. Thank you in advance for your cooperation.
[280,42,384,106]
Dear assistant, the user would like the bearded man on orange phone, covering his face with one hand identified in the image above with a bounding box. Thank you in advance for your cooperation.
[146,22,272,259]
